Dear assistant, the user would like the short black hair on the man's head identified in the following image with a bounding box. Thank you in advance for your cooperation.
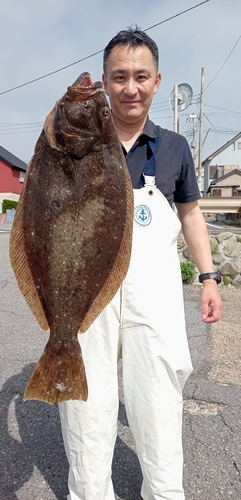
[103,26,159,73]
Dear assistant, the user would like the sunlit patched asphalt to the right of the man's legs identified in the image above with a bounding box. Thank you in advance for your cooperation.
[183,287,241,500]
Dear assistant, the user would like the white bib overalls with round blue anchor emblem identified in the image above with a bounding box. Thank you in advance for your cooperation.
[59,177,192,500]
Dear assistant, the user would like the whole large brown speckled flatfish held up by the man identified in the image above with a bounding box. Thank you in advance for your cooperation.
[10,73,133,404]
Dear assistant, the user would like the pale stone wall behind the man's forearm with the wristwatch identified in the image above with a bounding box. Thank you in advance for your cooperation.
[178,232,241,288]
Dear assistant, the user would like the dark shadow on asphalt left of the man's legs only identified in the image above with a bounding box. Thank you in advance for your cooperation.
[0,364,68,500]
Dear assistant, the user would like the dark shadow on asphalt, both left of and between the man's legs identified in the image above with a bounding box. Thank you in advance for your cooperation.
[0,364,142,500]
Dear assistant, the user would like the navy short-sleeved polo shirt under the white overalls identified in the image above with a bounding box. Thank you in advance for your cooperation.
[123,119,200,205]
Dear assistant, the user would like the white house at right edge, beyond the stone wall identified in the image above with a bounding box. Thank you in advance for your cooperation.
[202,132,241,197]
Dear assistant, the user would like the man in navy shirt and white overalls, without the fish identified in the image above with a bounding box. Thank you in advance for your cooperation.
[60,29,221,500]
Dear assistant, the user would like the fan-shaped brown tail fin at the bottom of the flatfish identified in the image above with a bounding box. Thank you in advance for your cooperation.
[23,343,88,405]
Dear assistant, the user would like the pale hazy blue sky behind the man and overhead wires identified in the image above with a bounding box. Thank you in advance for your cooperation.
[0,0,241,168]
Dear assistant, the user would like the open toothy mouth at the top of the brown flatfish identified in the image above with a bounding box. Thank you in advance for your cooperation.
[67,72,104,100]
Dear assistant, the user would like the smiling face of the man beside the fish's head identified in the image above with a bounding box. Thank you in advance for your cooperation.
[102,45,161,124]
